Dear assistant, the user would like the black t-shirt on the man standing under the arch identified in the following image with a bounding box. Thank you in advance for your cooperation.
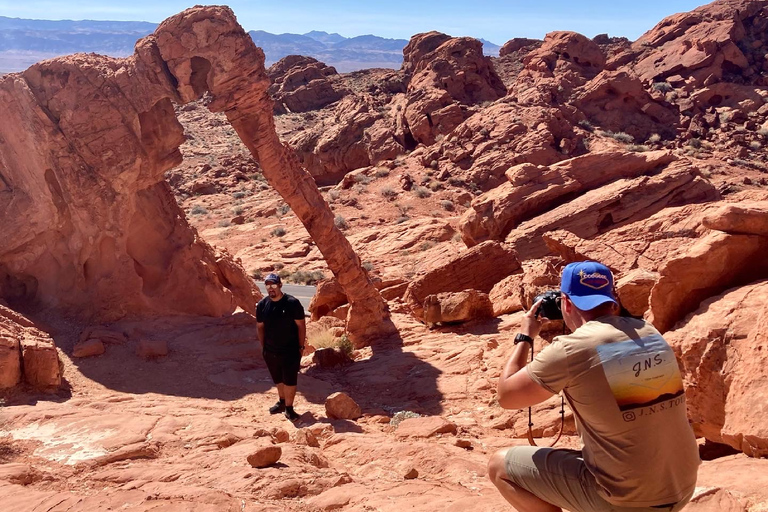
[256,294,304,354]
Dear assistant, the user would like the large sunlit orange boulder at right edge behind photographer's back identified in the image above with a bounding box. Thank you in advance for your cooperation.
[665,280,768,457]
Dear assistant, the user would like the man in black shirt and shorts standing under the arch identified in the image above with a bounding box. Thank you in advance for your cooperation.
[256,274,307,421]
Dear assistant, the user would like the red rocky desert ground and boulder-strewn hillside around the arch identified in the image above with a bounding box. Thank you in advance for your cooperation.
[0,0,768,511]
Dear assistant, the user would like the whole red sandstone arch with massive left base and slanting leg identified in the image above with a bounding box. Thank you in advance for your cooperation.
[0,6,394,346]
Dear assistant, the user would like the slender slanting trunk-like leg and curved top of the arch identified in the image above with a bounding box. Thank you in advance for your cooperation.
[149,7,394,346]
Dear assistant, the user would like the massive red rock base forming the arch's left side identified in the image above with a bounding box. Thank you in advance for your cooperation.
[0,43,259,320]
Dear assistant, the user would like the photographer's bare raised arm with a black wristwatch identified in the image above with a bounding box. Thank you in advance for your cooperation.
[496,302,553,409]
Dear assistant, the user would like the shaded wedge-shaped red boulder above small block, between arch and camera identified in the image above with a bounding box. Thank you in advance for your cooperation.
[403,241,520,318]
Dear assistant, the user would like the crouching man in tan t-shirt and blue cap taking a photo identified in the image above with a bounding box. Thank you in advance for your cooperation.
[488,261,700,512]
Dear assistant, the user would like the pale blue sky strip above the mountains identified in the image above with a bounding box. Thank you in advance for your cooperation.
[0,0,706,44]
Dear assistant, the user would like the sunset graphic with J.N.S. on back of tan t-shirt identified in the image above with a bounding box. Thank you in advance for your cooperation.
[597,335,683,421]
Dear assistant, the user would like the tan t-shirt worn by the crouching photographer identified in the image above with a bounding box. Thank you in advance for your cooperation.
[526,316,700,507]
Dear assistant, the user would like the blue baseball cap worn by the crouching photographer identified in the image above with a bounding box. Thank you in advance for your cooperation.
[560,261,616,311]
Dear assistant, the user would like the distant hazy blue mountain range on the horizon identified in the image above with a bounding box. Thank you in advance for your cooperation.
[0,16,499,73]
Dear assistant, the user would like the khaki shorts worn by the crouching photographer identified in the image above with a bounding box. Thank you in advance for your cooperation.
[504,446,693,512]
